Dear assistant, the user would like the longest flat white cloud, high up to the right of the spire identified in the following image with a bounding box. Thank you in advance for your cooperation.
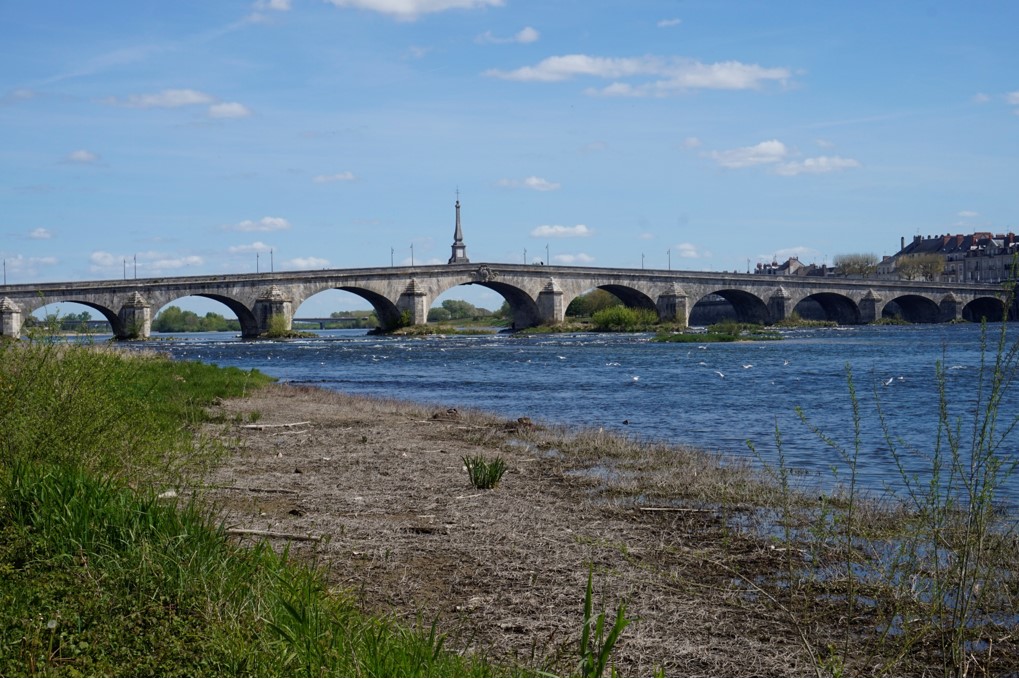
[485,54,791,97]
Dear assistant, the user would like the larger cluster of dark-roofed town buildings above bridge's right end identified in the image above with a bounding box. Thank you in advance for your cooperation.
[877,231,1019,282]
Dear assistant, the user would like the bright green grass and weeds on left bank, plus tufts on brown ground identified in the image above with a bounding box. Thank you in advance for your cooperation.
[0,338,626,676]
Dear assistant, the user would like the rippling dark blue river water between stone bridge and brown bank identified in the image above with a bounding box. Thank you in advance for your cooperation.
[127,324,1019,498]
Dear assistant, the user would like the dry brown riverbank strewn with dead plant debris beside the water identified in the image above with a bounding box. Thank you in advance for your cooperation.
[198,385,814,676]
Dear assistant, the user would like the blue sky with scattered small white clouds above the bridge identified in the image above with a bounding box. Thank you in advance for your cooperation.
[0,0,1019,313]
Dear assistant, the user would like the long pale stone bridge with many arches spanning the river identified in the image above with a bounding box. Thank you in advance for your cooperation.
[0,263,1004,340]
